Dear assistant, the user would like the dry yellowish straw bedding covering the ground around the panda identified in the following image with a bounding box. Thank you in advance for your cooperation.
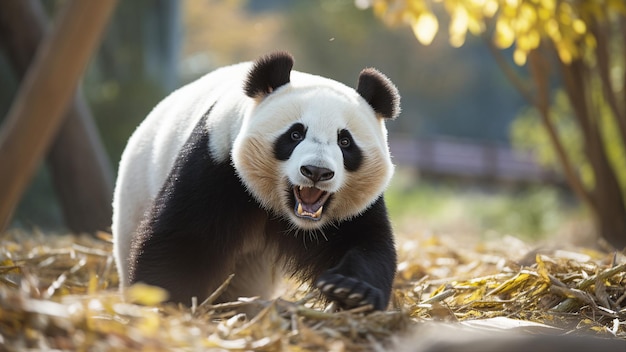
[0,232,626,351]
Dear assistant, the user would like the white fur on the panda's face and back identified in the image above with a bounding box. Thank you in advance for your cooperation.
[112,63,393,287]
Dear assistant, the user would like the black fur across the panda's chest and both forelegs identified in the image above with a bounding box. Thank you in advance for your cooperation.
[130,111,396,310]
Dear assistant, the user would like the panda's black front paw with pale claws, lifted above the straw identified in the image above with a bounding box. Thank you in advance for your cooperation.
[315,272,386,310]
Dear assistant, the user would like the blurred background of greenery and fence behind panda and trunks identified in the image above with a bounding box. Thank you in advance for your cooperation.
[0,0,620,246]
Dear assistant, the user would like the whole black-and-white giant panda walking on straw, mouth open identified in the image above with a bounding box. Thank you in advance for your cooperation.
[112,52,400,310]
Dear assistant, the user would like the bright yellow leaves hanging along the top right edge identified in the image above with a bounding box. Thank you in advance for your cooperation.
[372,0,626,65]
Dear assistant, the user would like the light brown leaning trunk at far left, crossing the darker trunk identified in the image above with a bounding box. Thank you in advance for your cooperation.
[0,0,115,231]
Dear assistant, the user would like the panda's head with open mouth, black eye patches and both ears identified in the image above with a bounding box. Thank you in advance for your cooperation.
[232,53,400,230]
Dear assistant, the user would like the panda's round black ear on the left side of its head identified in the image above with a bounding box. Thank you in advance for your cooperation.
[244,52,293,98]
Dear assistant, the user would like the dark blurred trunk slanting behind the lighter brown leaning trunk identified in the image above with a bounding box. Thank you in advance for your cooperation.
[0,0,113,233]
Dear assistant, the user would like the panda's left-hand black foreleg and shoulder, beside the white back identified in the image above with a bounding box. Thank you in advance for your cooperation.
[130,108,265,304]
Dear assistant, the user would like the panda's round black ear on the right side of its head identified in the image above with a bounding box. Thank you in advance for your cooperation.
[356,68,400,119]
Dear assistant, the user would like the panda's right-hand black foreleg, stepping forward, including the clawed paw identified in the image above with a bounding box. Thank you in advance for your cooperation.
[315,196,397,310]
